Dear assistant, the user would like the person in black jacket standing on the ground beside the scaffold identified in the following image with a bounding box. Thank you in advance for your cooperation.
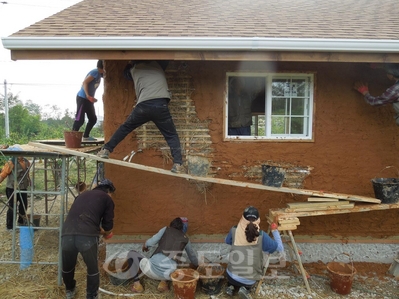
[61,179,115,299]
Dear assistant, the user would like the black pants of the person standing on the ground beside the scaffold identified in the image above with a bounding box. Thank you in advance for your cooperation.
[61,236,100,299]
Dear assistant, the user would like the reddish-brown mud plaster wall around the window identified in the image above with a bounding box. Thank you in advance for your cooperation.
[103,61,399,238]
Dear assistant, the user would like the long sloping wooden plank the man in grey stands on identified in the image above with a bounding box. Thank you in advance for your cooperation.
[29,142,381,203]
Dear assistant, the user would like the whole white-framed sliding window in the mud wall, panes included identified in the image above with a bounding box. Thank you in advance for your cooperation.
[225,73,313,140]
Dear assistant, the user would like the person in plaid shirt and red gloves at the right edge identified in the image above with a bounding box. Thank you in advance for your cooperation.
[353,63,399,126]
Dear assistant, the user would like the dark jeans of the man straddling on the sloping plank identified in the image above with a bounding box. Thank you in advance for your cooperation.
[104,99,183,164]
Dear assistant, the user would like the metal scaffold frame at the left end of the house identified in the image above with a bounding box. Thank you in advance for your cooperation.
[0,149,99,285]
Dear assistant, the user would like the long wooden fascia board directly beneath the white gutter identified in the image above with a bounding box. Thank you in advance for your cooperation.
[11,49,399,63]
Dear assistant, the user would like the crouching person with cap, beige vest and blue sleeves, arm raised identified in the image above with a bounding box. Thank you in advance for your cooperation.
[225,206,284,299]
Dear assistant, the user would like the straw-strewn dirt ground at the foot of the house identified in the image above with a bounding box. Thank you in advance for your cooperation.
[0,226,399,299]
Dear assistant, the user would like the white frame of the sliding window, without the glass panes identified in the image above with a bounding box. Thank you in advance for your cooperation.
[224,72,315,142]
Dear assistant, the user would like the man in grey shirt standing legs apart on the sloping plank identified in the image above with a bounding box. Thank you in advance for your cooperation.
[97,60,185,173]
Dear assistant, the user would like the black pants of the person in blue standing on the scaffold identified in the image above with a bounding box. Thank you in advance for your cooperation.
[72,96,97,137]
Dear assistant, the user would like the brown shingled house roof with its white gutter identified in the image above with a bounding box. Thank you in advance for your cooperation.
[2,0,399,61]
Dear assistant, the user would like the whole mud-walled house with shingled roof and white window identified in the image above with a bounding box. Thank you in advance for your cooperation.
[2,0,399,238]
